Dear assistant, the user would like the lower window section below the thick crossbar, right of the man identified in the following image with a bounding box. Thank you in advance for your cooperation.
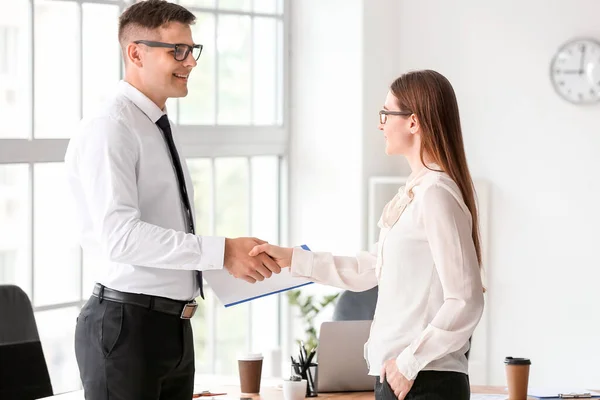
[188,156,280,374]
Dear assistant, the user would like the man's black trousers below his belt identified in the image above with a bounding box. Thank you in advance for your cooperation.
[75,296,195,400]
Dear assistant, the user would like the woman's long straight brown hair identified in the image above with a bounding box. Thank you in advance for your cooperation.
[390,70,481,267]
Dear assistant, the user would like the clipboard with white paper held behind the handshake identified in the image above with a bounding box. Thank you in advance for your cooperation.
[202,244,313,307]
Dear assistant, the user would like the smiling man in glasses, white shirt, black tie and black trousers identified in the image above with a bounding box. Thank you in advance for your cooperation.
[65,0,280,400]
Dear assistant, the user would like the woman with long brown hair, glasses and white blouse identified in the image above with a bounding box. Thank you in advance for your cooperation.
[250,70,483,400]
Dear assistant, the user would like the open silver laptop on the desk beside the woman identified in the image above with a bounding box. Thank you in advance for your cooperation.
[316,321,375,393]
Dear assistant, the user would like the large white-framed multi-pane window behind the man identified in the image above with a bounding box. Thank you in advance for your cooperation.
[0,0,287,393]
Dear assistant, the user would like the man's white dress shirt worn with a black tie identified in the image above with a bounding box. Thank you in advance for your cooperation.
[65,81,225,300]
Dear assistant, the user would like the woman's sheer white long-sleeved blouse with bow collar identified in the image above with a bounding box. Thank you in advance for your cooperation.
[291,165,484,380]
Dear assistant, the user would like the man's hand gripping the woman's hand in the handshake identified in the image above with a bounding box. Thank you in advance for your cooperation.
[223,238,281,283]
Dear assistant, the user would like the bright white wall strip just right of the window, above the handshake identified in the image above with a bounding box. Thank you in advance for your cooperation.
[289,0,362,254]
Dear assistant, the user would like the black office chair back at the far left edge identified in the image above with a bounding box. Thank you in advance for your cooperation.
[0,285,53,400]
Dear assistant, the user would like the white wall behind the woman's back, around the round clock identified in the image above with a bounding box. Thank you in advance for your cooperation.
[396,0,600,387]
